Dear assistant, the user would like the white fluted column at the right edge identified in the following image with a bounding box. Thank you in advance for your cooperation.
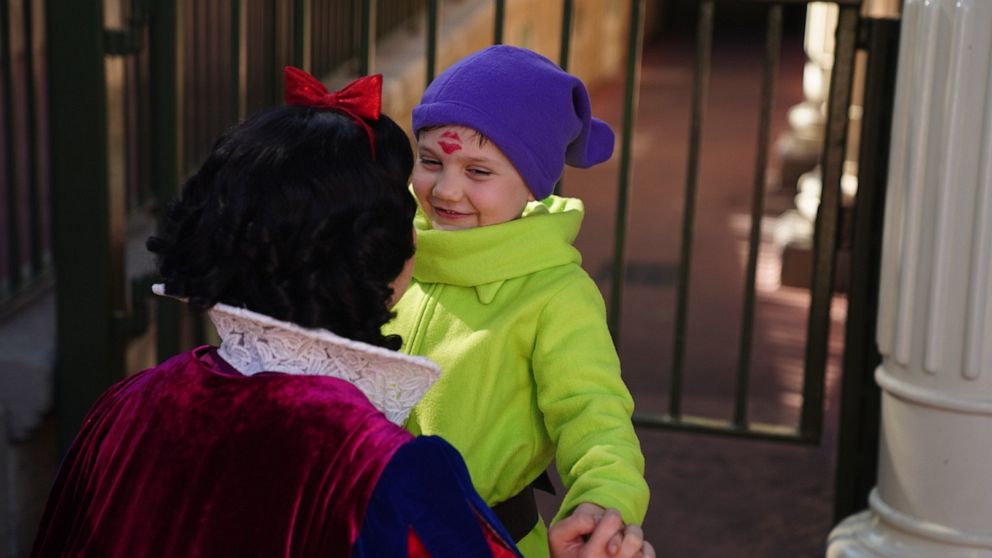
[827,0,992,558]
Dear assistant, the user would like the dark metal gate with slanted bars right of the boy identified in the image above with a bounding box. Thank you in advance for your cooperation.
[628,0,859,443]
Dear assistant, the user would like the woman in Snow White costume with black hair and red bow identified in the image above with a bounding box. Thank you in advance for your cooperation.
[33,68,650,557]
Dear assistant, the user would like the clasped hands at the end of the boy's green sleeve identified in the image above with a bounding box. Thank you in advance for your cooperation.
[548,510,655,558]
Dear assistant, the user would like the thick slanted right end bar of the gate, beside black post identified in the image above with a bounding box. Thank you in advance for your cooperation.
[799,5,858,442]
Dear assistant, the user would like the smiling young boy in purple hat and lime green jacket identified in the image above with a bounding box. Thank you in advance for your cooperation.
[387,45,648,556]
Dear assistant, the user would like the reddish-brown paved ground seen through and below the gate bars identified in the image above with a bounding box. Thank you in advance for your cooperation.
[541,27,844,558]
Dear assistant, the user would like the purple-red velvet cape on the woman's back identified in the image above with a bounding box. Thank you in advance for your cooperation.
[33,347,412,557]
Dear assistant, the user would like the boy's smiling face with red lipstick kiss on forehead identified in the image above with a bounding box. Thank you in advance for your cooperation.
[412,126,534,230]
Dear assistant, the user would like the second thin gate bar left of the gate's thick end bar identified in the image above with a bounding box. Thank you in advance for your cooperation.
[668,0,714,417]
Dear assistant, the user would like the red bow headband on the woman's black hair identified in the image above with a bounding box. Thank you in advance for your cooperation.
[283,66,382,159]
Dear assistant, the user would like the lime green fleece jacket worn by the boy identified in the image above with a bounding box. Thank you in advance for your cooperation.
[386,196,648,556]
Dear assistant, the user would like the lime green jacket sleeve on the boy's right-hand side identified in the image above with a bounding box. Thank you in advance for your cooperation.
[533,274,649,523]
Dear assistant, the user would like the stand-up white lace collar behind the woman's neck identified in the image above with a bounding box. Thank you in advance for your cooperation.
[152,284,441,425]
